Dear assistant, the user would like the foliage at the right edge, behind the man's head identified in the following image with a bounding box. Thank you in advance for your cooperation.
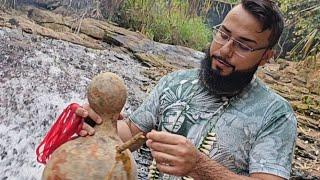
[279,0,320,60]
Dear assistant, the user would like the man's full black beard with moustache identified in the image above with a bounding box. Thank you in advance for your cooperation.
[199,52,258,96]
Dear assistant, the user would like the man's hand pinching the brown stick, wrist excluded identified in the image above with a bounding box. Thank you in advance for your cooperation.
[147,130,200,176]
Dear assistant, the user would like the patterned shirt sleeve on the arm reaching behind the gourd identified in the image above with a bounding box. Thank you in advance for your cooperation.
[129,76,168,132]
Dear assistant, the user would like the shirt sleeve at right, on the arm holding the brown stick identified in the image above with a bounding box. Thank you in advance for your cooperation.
[249,112,297,179]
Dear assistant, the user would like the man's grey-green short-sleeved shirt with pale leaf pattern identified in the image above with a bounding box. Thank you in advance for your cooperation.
[129,69,297,179]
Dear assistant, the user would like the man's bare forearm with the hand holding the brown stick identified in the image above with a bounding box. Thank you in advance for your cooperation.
[147,131,282,180]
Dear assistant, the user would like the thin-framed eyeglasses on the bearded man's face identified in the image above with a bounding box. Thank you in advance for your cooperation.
[213,26,269,57]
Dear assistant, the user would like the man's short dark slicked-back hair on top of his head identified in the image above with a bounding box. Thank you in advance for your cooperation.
[241,0,284,49]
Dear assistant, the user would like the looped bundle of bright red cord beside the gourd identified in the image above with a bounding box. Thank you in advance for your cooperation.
[36,103,83,164]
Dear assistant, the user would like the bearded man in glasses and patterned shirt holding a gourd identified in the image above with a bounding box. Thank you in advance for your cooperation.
[77,0,297,180]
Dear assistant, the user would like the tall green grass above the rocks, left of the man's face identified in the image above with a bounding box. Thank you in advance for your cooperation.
[119,0,211,50]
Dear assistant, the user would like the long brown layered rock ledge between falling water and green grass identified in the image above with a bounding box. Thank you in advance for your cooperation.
[0,7,204,68]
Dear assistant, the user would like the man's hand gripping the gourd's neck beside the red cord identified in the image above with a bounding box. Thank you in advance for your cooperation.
[76,104,123,136]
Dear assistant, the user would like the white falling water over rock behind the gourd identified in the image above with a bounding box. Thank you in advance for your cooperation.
[0,29,148,180]
